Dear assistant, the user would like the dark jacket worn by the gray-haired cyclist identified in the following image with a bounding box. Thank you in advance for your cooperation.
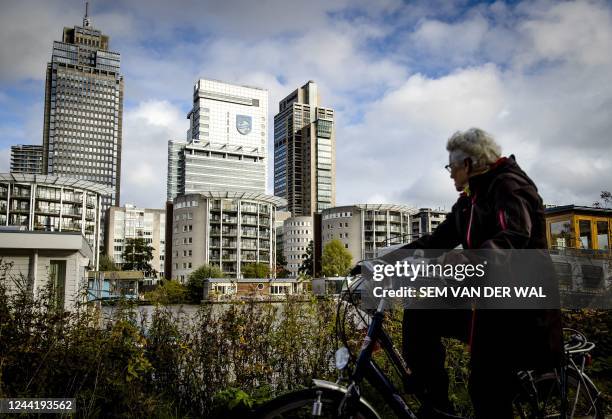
[405,156,563,369]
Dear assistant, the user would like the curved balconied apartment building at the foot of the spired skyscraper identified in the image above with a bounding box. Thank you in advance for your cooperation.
[0,173,112,266]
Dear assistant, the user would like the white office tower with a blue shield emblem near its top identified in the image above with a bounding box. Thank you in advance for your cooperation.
[167,79,268,200]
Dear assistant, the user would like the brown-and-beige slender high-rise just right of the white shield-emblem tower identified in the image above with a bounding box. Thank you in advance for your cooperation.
[274,80,336,217]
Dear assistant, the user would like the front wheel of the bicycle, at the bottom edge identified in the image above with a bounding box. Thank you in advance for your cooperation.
[255,388,377,419]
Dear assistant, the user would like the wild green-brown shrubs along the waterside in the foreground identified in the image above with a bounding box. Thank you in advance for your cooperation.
[0,262,612,418]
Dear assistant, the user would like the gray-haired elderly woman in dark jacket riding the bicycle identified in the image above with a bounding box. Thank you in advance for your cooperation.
[403,128,562,418]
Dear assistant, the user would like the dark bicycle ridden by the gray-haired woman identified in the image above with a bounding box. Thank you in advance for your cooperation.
[255,266,604,419]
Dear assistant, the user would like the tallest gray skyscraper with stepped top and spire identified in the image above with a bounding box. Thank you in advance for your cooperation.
[43,2,123,209]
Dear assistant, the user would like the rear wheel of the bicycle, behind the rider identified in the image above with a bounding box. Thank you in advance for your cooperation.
[515,367,604,419]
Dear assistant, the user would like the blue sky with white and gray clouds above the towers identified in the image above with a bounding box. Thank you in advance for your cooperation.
[0,0,612,210]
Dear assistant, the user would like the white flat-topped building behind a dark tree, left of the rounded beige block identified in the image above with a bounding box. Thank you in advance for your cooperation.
[104,204,166,275]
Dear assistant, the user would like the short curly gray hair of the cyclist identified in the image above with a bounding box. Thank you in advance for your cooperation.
[446,128,501,167]
